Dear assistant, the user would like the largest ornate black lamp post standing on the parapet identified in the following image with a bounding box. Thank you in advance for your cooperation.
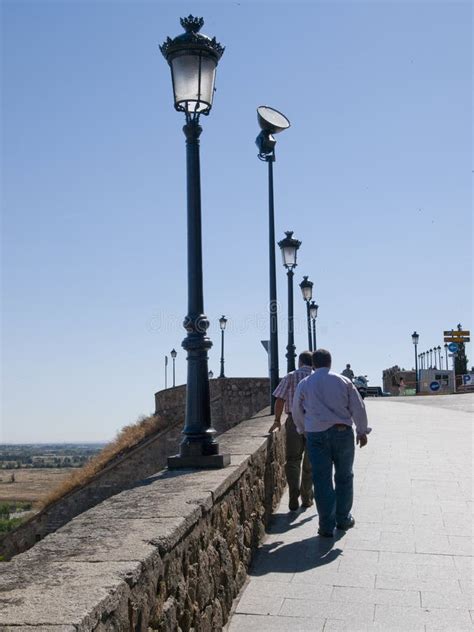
[160,15,230,468]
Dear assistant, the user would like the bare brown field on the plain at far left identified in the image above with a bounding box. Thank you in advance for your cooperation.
[0,467,74,504]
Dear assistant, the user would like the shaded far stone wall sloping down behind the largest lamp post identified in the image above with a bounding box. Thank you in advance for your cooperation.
[0,378,269,559]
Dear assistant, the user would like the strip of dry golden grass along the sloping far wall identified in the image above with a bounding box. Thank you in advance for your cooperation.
[41,415,168,509]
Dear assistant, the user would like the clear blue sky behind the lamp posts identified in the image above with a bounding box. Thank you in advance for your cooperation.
[0,0,473,442]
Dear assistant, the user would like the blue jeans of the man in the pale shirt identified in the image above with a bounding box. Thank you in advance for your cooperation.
[306,426,354,532]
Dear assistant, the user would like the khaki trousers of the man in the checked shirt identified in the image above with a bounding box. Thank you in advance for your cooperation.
[285,414,313,503]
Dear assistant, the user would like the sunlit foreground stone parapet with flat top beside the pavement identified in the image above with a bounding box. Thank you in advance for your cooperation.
[0,414,285,632]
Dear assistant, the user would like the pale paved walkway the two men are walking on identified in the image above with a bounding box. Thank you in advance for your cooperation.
[227,394,474,632]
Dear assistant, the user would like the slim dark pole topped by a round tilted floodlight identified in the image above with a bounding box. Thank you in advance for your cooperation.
[255,105,290,414]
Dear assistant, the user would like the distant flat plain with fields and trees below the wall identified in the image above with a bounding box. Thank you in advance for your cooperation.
[0,443,105,535]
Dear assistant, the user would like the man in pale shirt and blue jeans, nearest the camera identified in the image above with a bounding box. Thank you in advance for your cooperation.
[292,349,371,537]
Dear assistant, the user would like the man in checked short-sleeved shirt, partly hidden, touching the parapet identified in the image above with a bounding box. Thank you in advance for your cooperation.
[269,351,313,511]
